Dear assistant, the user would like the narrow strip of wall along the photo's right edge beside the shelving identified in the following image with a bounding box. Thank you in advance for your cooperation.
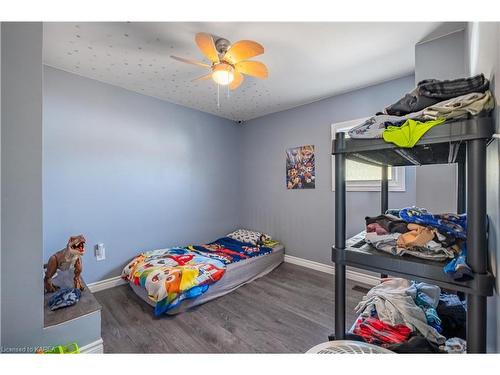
[467,22,500,352]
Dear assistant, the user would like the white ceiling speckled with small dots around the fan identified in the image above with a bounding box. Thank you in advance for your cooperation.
[44,22,439,120]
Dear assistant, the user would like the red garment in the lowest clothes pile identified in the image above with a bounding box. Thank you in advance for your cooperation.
[353,317,412,344]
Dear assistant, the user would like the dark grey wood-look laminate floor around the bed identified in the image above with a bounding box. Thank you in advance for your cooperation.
[95,263,367,353]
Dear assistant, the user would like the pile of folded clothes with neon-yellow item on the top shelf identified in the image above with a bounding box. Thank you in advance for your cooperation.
[349,74,495,147]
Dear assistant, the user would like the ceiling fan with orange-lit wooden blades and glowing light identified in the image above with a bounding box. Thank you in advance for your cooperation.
[170,33,268,90]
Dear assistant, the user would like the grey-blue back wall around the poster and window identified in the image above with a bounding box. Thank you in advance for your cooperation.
[240,76,415,264]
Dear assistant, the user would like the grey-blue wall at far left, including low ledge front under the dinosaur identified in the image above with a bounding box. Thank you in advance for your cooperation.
[0,22,101,351]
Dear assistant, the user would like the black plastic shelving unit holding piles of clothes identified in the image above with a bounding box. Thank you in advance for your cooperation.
[332,116,495,353]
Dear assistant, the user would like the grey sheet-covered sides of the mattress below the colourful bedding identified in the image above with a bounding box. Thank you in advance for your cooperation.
[129,245,285,315]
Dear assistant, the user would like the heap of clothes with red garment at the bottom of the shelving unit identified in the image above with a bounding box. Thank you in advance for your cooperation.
[348,278,466,353]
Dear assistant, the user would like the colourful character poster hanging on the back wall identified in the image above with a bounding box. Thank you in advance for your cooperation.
[286,145,316,189]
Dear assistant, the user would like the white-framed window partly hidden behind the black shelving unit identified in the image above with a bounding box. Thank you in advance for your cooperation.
[331,118,406,191]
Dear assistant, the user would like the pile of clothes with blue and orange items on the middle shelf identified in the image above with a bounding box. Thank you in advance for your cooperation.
[365,207,473,281]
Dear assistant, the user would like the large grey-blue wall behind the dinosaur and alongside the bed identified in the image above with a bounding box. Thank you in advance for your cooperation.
[43,67,240,282]
